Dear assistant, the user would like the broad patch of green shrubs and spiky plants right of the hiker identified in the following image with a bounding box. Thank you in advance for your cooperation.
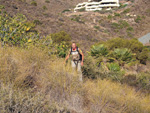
[83,38,150,91]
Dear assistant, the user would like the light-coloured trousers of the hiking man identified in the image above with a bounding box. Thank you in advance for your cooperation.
[71,61,82,81]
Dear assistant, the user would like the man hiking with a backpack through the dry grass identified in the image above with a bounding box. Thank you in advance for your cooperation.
[65,42,84,81]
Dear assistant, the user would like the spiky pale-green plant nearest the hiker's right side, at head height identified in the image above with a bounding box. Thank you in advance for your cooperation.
[91,44,108,56]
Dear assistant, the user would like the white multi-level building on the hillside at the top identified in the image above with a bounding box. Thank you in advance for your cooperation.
[74,0,120,12]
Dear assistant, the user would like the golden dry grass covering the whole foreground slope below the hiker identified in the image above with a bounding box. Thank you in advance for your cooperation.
[0,47,150,113]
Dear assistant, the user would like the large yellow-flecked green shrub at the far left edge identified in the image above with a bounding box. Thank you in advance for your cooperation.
[0,13,38,46]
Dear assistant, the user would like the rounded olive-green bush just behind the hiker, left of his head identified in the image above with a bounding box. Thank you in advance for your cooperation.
[51,31,71,45]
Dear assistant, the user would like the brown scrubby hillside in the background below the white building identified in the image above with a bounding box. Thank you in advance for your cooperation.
[0,0,150,48]
